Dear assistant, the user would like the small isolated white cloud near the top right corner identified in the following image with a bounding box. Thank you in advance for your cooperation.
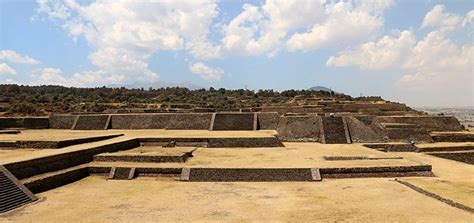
[421,5,461,31]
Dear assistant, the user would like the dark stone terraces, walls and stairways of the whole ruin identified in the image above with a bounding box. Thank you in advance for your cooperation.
[0,98,474,212]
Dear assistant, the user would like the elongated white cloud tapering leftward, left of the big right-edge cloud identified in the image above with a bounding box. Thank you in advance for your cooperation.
[326,30,416,70]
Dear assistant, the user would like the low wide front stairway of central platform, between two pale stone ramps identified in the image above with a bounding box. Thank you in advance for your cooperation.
[181,168,321,182]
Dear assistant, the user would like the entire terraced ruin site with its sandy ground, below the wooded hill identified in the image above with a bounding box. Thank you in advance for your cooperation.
[0,97,474,222]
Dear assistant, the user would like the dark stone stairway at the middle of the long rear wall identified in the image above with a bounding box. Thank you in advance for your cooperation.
[211,113,257,130]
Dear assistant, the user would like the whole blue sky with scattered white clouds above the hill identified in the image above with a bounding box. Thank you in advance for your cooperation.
[0,0,474,106]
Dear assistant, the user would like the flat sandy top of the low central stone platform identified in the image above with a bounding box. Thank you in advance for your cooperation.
[186,143,422,168]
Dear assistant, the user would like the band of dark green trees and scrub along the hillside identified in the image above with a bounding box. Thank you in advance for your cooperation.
[0,85,353,116]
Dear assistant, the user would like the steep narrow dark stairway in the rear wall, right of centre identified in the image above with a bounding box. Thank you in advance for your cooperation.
[322,117,351,144]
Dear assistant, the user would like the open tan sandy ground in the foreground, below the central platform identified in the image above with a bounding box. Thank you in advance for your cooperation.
[0,176,474,222]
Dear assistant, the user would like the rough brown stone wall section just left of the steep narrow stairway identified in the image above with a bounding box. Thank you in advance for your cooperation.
[277,115,322,142]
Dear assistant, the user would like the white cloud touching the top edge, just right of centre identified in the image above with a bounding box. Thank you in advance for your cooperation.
[222,0,324,56]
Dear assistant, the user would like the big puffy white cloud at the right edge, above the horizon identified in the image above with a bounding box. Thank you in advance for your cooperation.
[396,31,474,106]
